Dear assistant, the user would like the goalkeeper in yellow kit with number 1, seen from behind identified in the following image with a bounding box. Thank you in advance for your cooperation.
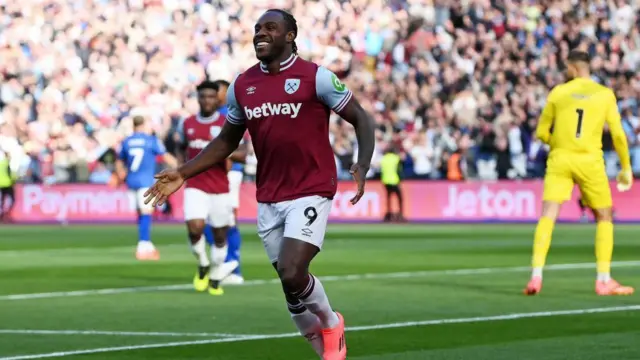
[525,51,633,295]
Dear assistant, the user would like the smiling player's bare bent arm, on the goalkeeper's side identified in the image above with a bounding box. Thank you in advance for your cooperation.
[339,97,376,204]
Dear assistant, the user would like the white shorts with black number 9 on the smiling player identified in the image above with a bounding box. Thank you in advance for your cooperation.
[258,196,331,263]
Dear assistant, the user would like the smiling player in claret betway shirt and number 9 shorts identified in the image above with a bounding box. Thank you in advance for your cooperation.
[146,10,375,360]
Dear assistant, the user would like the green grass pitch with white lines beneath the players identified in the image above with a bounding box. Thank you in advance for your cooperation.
[0,225,640,360]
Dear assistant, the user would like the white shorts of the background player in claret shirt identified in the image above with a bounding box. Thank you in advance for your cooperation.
[184,188,235,228]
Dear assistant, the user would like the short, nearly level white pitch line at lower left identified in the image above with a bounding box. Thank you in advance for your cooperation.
[0,329,242,338]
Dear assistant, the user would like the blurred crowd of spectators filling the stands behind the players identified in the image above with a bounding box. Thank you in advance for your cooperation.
[0,0,640,183]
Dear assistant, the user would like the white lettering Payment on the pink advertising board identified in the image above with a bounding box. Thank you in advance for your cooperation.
[21,185,135,221]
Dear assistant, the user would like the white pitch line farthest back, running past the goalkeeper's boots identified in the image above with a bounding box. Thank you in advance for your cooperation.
[0,261,640,301]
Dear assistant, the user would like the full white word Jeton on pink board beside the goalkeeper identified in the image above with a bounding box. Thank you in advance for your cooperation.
[442,185,536,219]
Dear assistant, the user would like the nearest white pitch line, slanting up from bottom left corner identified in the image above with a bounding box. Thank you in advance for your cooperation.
[0,305,640,360]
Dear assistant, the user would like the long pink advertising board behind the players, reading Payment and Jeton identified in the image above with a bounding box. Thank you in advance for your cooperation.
[12,181,640,223]
